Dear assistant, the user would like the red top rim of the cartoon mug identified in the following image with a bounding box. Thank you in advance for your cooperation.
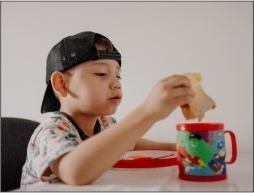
[176,123,224,131]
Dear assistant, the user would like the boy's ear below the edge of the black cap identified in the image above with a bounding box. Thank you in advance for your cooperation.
[51,71,68,97]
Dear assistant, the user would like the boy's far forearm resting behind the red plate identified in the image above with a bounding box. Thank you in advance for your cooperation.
[134,138,176,151]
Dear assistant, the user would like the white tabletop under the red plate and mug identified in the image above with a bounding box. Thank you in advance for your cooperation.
[15,153,253,192]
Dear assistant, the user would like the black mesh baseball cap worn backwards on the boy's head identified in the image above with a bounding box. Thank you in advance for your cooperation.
[41,31,121,113]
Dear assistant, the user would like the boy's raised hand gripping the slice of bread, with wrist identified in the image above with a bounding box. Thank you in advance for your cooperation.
[142,75,194,121]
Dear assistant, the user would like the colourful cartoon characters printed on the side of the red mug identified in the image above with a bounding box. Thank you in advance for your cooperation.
[177,132,226,174]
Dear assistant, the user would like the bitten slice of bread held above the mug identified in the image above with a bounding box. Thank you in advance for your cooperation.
[181,73,216,121]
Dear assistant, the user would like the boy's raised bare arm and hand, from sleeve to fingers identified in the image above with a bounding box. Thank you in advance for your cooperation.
[50,76,194,185]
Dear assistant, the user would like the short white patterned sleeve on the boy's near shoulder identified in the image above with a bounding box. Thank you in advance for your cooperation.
[31,117,81,180]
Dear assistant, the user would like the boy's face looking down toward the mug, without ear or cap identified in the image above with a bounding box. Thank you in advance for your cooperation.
[64,59,122,116]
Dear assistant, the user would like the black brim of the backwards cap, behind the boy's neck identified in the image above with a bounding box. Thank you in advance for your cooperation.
[41,82,60,113]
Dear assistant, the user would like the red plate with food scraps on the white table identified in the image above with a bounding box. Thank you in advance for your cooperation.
[113,150,177,168]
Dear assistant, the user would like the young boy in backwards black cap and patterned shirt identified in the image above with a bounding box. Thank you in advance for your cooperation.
[21,32,194,186]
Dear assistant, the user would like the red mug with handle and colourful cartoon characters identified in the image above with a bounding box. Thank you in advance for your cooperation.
[176,123,237,181]
